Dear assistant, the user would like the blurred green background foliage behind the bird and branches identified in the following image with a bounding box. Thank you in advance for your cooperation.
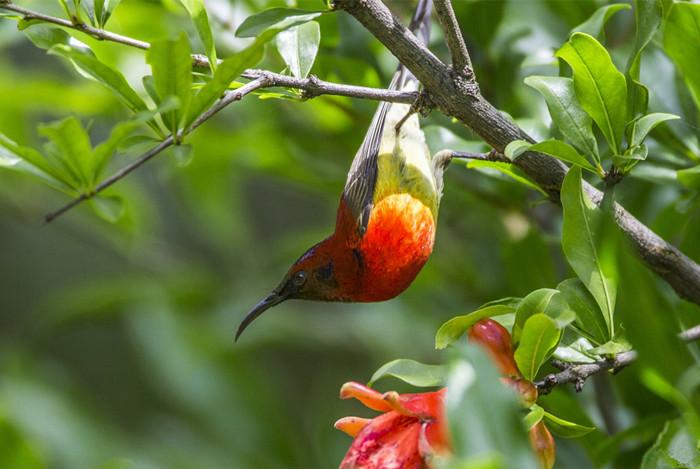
[0,0,700,468]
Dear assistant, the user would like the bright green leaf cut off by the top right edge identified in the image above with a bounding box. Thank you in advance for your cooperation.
[664,3,700,106]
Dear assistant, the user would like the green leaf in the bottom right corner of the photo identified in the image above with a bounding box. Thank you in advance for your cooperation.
[641,419,700,469]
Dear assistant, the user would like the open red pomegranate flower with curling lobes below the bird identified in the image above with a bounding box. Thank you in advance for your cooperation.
[335,382,449,469]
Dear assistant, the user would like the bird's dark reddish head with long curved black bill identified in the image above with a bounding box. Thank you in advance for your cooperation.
[236,237,356,340]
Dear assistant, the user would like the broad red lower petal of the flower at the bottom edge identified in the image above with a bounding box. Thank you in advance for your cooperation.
[340,411,423,469]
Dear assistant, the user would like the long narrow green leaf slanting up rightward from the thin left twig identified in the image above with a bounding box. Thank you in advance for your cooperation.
[185,43,265,128]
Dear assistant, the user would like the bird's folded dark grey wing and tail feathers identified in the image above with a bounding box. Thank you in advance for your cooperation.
[343,0,432,238]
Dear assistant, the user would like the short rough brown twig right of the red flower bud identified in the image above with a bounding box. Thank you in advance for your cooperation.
[535,325,700,395]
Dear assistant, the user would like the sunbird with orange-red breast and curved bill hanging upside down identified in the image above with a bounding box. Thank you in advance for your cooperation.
[236,0,450,340]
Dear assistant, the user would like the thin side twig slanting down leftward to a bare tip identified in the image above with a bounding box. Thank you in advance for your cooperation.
[44,77,269,223]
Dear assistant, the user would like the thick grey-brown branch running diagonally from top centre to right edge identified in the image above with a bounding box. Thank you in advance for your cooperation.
[335,0,700,304]
